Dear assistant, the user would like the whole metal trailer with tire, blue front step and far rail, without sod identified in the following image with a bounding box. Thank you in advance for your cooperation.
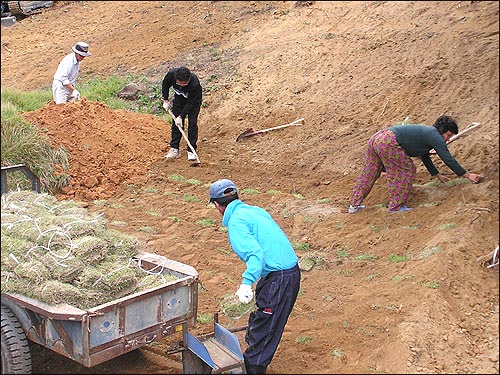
[1,164,247,374]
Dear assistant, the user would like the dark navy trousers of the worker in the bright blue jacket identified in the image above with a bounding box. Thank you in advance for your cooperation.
[243,265,300,367]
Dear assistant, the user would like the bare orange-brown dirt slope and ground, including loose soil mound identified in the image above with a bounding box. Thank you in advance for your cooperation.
[1,1,499,373]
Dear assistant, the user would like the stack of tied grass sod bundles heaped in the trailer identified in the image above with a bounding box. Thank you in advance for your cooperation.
[1,191,177,310]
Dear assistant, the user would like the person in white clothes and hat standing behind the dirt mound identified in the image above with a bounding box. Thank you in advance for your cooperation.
[52,42,90,104]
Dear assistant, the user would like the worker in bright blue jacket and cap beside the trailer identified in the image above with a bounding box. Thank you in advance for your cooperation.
[210,179,300,374]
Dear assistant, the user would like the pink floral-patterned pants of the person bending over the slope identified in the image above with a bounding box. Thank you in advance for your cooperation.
[351,129,417,210]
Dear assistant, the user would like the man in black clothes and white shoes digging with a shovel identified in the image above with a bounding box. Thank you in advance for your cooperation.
[161,66,202,160]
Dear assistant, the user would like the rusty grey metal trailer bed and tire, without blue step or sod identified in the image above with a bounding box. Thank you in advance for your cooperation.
[1,253,199,374]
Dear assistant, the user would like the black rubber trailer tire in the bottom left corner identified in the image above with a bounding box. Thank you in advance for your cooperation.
[2,305,32,374]
